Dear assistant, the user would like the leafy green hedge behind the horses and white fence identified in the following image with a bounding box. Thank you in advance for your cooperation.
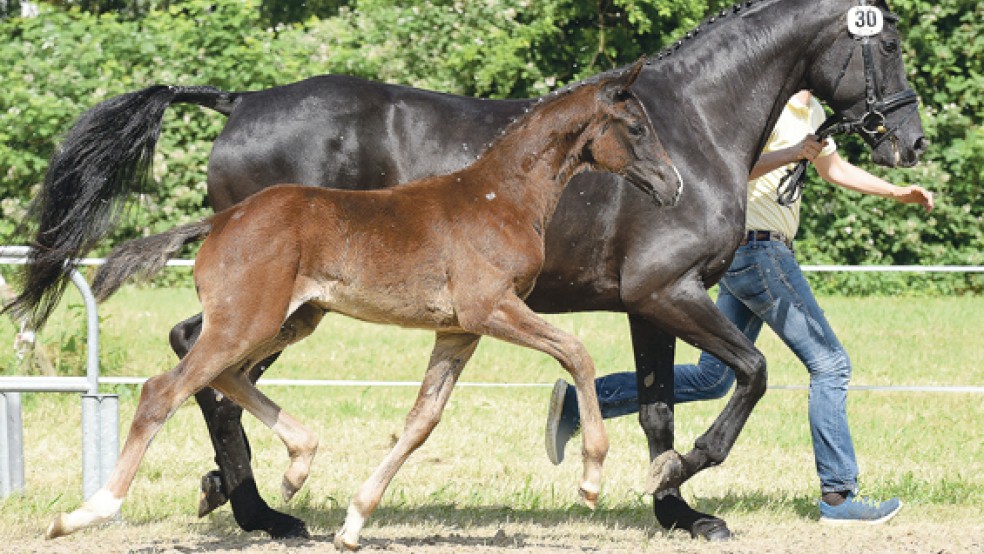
[0,0,984,294]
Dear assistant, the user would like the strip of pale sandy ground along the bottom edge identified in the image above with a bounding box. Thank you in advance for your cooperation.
[0,510,984,554]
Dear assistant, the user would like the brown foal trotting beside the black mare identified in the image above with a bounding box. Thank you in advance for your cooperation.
[48,61,682,548]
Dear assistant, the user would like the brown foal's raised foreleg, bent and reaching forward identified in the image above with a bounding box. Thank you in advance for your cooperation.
[480,296,608,509]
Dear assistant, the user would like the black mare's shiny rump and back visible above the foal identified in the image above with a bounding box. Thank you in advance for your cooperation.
[208,75,531,209]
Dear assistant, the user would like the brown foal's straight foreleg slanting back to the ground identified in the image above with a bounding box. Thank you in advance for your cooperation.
[335,332,481,550]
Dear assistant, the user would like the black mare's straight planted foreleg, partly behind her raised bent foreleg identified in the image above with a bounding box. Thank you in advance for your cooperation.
[629,315,731,540]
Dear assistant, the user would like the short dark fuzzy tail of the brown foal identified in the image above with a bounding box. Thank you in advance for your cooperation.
[92,218,212,302]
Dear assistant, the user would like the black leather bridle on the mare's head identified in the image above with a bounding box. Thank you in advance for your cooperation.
[777,0,919,206]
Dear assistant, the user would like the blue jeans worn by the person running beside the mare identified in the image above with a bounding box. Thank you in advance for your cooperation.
[564,241,858,492]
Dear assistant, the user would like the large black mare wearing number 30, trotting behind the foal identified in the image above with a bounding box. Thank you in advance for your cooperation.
[11,0,926,538]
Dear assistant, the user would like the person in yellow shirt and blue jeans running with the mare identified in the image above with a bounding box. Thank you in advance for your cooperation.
[546,91,933,524]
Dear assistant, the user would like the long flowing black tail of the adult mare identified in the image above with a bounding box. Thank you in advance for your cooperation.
[4,86,239,328]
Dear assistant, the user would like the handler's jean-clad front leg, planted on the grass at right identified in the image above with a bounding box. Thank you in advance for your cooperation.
[721,242,858,492]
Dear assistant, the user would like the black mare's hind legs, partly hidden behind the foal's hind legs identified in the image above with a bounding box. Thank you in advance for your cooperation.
[170,314,310,538]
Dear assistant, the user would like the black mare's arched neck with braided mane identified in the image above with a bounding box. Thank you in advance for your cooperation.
[634,0,852,175]
